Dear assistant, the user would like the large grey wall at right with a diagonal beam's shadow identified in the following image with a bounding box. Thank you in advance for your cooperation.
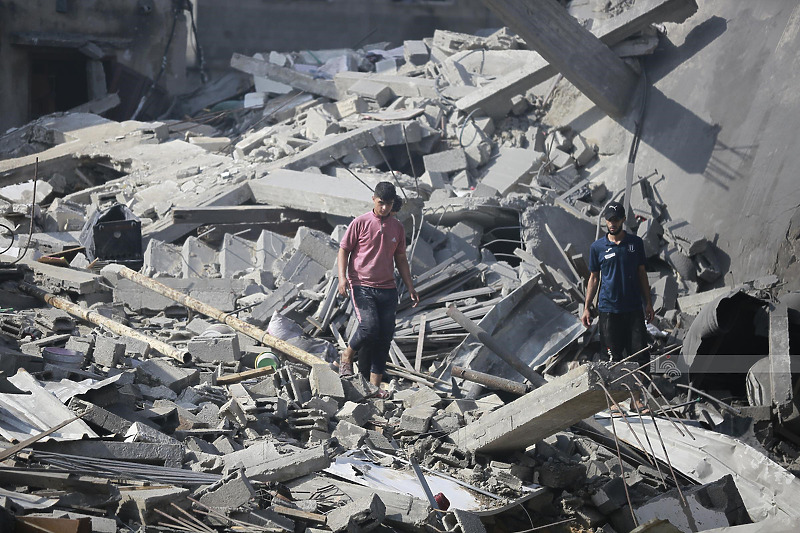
[542,0,800,290]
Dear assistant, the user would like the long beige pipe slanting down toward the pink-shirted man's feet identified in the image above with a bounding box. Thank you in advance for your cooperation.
[105,264,326,366]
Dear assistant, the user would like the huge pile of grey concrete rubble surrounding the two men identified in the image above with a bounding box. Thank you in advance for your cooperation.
[0,2,800,533]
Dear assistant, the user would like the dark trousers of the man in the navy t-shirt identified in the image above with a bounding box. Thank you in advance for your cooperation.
[600,310,650,372]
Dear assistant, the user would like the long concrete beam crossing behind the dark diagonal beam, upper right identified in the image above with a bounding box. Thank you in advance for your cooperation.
[456,0,697,118]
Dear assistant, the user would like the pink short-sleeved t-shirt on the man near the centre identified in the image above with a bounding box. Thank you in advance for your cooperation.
[339,211,406,289]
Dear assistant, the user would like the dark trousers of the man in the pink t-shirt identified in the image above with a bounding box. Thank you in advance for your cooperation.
[350,285,397,379]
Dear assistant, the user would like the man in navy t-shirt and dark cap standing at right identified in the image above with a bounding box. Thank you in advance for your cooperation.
[581,202,655,374]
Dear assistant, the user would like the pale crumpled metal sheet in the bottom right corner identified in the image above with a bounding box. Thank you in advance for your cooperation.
[595,417,800,523]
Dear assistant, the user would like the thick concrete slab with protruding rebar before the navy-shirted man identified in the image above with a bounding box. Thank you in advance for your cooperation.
[450,363,635,453]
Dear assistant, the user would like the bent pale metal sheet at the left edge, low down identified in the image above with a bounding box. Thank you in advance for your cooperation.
[0,369,97,442]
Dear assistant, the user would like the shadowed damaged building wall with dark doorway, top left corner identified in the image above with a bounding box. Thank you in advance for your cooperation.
[0,0,187,131]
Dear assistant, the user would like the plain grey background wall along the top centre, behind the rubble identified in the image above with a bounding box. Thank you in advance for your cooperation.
[196,0,502,71]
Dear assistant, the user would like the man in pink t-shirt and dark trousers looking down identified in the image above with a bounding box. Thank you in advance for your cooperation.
[338,181,419,397]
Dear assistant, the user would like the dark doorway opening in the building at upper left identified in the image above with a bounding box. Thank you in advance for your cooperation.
[28,48,89,120]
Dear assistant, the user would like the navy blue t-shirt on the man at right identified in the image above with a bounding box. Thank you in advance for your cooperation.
[589,232,647,313]
